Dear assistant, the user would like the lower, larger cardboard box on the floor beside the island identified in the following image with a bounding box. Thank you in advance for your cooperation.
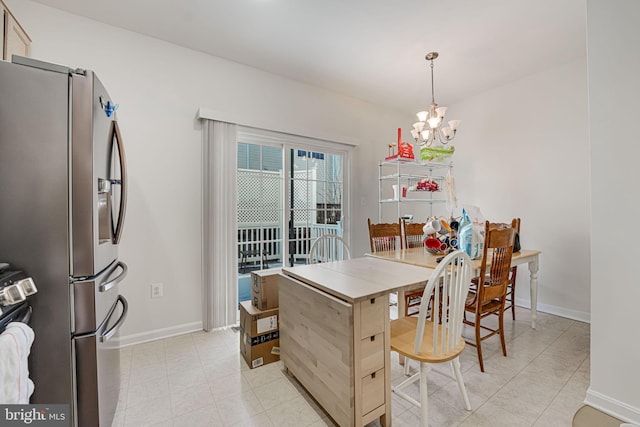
[240,301,280,369]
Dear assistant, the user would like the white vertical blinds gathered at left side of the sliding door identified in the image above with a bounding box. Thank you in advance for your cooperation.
[202,120,238,331]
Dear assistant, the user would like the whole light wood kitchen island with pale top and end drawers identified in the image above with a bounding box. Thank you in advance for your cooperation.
[279,257,432,426]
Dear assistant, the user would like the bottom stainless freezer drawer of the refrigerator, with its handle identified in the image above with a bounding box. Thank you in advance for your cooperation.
[73,295,128,427]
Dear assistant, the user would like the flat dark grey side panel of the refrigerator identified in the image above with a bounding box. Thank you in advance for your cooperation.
[0,58,72,403]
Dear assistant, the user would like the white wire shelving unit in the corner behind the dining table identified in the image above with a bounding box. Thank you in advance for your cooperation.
[378,160,453,222]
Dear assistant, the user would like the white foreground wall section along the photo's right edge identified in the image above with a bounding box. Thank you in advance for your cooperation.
[586,0,640,424]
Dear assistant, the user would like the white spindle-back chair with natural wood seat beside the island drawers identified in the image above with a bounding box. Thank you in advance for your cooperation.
[390,251,471,427]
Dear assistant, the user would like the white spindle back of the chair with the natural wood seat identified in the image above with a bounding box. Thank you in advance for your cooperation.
[414,251,471,356]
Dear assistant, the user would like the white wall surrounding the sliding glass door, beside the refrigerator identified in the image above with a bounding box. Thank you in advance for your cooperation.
[7,0,408,342]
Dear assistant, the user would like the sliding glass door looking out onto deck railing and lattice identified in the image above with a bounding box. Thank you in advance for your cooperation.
[237,132,348,301]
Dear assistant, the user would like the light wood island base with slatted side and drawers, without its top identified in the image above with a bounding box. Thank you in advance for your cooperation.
[279,276,391,426]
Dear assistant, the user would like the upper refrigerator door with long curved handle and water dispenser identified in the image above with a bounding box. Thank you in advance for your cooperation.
[70,71,126,277]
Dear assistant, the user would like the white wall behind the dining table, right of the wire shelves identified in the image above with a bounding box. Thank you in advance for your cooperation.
[448,57,590,321]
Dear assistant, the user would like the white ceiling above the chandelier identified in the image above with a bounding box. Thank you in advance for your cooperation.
[35,0,586,113]
